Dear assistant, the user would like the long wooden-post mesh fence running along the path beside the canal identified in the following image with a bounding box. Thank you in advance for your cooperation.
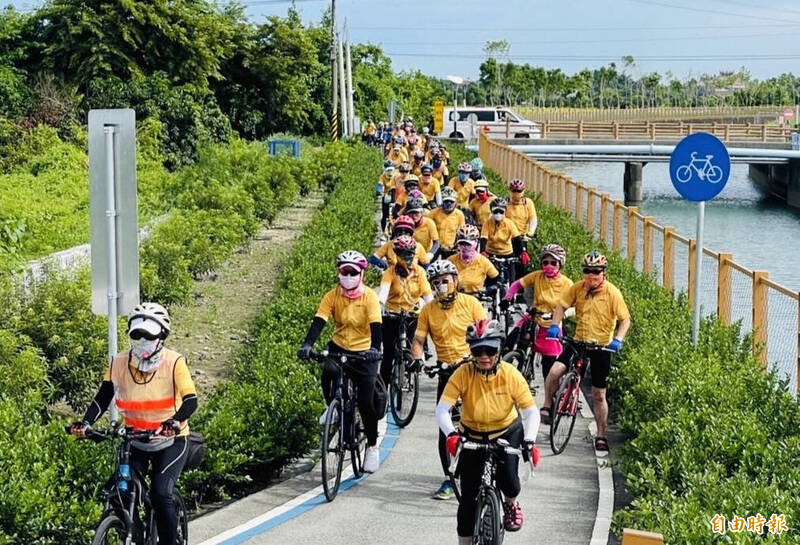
[479,135,800,394]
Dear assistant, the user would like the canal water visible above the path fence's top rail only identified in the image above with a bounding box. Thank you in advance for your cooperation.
[549,162,800,291]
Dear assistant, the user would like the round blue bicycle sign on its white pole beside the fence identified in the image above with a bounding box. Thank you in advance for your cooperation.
[669,132,731,346]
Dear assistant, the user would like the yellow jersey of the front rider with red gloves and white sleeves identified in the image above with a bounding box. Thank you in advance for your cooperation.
[442,361,536,432]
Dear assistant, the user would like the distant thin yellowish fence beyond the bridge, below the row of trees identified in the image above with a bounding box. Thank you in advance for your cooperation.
[514,106,792,121]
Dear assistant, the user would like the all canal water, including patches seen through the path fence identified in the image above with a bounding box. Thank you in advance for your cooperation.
[549,162,800,392]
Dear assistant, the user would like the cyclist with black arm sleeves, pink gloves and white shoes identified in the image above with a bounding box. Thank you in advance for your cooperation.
[297,250,383,473]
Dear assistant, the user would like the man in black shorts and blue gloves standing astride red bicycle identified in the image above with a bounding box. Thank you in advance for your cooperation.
[542,250,631,451]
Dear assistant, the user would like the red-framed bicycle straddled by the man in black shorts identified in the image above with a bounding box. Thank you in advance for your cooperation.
[550,336,610,454]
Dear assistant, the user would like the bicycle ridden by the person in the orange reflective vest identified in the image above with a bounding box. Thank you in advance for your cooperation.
[65,426,189,545]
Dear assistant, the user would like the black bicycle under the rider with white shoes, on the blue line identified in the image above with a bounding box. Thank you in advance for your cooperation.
[310,350,367,501]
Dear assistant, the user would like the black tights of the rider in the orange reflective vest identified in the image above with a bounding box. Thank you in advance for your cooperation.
[131,437,186,545]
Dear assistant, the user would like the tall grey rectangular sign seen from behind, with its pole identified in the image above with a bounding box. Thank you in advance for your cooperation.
[89,109,139,421]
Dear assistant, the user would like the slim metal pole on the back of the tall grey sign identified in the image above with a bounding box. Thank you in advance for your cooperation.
[103,125,119,423]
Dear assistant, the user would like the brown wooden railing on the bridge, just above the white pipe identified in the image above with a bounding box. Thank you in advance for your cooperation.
[541,120,792,142]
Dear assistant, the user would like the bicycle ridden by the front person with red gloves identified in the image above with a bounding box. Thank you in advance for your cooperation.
[461,439,533,545]
